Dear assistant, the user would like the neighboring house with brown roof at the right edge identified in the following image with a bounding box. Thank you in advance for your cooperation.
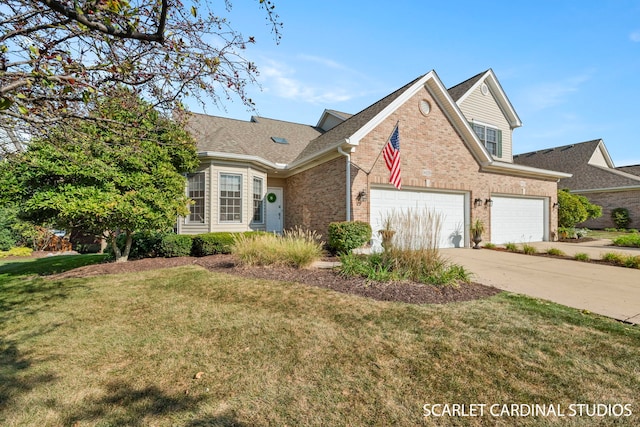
[514,139,640,229]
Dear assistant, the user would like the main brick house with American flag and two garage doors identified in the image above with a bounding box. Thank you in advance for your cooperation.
[178,70,569,247]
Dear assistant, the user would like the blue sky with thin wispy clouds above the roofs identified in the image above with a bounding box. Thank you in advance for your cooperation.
[190,0,640,166]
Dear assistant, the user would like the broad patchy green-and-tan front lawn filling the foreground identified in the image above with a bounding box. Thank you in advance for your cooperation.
[0,261,640,427]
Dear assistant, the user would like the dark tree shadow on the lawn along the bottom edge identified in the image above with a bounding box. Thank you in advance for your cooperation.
[63,381,232,427]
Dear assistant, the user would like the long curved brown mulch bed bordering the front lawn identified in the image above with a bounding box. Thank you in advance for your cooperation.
[50,255,501,304]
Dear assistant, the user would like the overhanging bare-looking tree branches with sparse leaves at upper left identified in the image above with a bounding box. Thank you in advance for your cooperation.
[0,0,281,155]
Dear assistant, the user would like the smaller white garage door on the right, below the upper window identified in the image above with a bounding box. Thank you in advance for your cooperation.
[491,196,547,244]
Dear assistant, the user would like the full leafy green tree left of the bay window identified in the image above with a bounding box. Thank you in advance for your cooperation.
[0,90,198,261]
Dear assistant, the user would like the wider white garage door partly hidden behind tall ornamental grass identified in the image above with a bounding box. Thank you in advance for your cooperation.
[370,189,467,251]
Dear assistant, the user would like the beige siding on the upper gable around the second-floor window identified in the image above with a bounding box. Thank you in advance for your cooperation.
[459,87,513,163]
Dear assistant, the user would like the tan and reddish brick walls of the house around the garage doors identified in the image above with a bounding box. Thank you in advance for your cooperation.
[285,88,557,241]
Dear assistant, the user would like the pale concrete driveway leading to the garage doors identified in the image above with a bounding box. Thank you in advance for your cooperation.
[442,241,640,325]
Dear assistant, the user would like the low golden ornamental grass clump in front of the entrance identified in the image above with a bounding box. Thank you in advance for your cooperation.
[232,228,324,268]
